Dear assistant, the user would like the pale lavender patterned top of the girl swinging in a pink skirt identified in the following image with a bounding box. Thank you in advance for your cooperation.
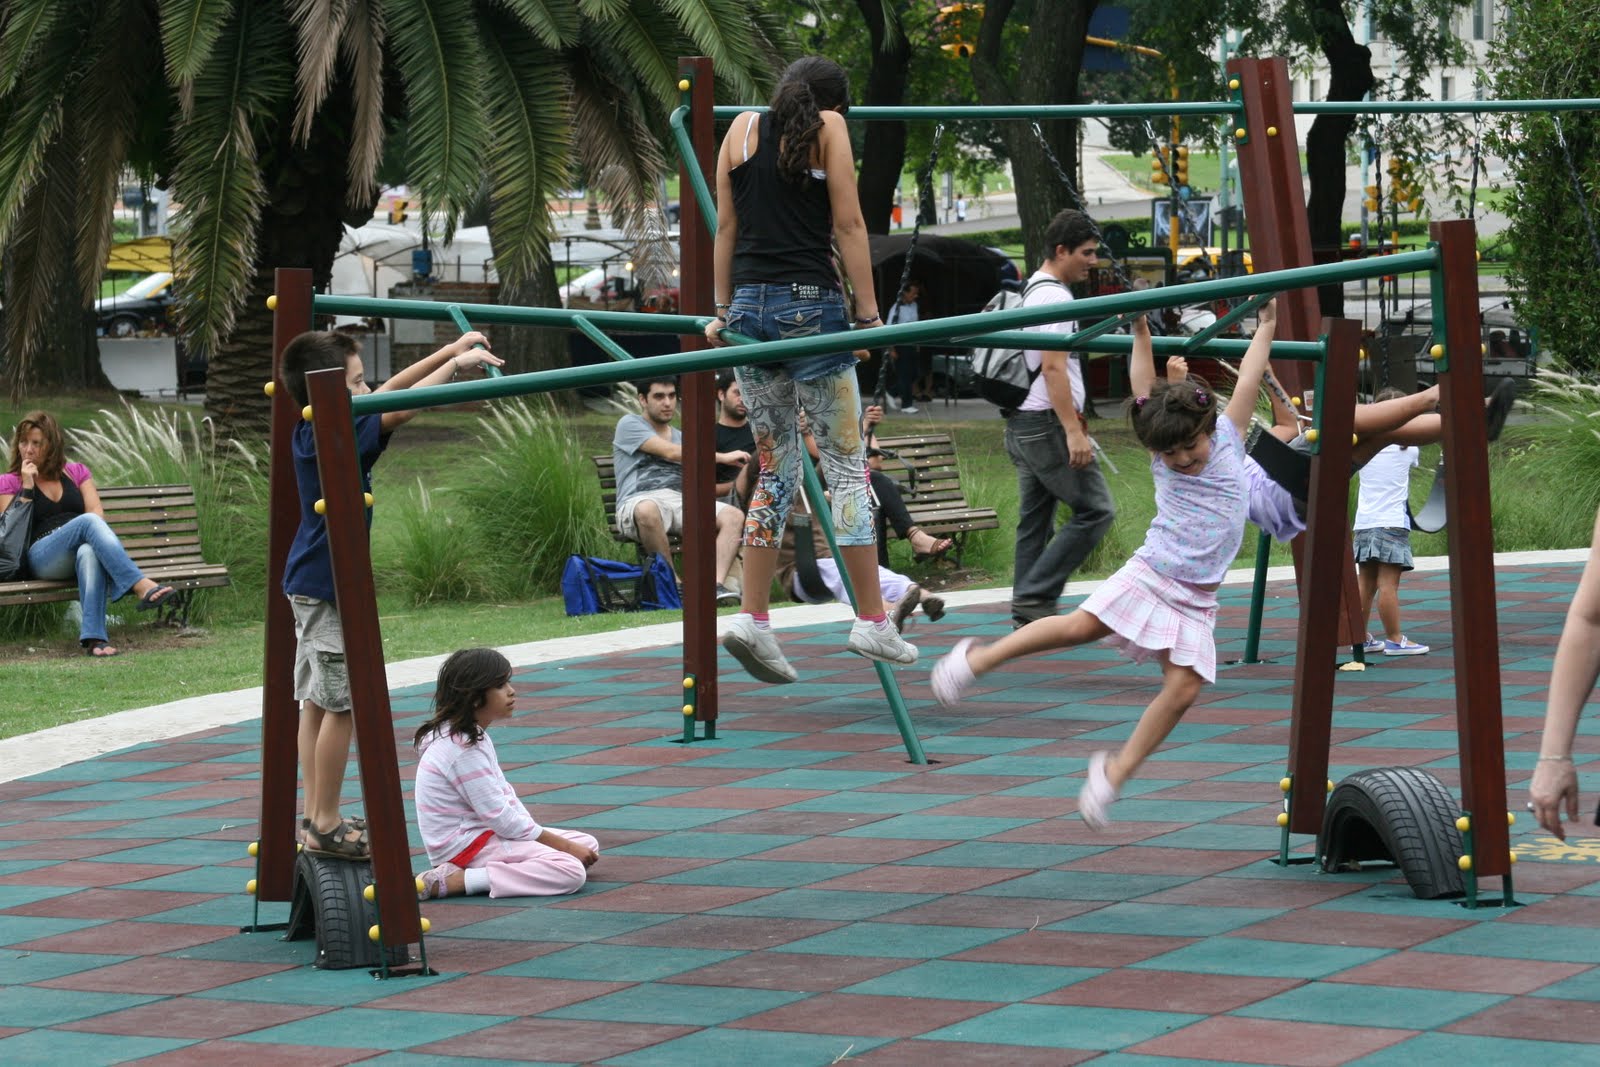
[1133,414,1250,585]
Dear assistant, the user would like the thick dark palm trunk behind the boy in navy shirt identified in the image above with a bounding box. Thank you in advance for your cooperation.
[205,80,378,442]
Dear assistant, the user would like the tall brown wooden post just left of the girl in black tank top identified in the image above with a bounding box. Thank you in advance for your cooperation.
[678,56,717,723]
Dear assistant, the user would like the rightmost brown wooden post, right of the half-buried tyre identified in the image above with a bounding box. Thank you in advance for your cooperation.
[1429,219,1510,877]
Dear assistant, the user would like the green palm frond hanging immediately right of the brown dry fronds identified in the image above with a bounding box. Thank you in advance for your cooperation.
[386,0,490,240]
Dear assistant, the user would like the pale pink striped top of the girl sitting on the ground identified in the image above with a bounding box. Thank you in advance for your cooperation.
[413,731,544,865]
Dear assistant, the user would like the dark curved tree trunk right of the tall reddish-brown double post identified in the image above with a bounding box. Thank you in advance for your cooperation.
[1306,0,1378,318]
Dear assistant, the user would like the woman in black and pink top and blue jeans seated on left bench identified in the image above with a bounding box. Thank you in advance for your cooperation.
[0,411,173,659]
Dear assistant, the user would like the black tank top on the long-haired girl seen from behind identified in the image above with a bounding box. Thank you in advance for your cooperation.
[728,112,838,290]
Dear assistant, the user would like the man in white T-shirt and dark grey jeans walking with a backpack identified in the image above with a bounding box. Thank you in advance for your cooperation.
[1002,210,1117,627]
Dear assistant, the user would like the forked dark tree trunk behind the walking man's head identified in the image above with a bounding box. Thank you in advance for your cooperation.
[973,0,1099,267]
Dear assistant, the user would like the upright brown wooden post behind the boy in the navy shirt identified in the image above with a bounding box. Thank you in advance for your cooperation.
[256,267,310,901]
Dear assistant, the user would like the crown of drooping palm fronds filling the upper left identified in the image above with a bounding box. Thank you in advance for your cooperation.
[0,0,786,434]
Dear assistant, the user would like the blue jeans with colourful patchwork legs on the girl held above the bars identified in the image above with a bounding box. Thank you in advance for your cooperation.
[726,285,875,549]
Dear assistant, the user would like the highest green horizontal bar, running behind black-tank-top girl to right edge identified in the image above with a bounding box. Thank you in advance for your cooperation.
[712,98,1600,122]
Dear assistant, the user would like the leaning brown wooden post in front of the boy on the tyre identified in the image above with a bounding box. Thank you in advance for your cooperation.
[306,368,422,945]
